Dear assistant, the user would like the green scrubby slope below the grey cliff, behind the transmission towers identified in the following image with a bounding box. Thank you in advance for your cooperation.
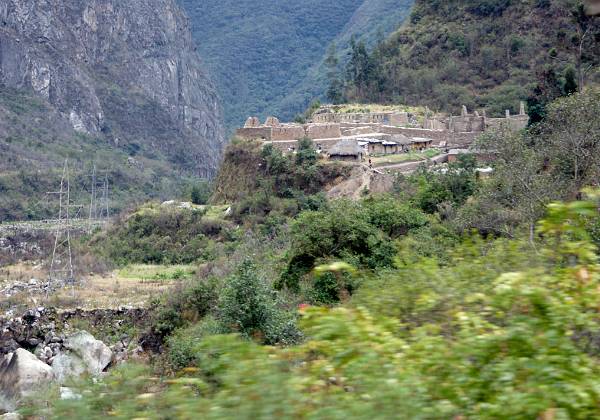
[0,88,198,222]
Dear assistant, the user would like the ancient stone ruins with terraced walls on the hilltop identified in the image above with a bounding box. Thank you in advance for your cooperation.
[236,103,529,161]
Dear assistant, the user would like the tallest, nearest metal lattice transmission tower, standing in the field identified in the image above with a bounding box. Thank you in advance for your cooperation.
[48,160,80,291]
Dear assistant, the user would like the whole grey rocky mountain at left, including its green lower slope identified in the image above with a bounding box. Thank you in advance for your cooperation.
[0,0,224,221]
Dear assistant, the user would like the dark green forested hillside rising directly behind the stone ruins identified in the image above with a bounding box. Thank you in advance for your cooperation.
[332,0,600,115]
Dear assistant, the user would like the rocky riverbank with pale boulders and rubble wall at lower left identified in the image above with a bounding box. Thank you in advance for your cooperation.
[0,308,154,414]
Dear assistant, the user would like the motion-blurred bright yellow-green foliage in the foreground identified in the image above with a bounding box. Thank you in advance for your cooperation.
[27,193,600,419]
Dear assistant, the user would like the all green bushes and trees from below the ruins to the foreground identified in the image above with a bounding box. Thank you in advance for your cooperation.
[23,89,600,419]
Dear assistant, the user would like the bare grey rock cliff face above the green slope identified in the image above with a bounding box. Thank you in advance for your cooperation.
[0,0,224,175]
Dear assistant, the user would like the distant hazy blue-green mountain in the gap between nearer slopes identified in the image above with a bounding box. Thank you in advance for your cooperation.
[179,0,413,128]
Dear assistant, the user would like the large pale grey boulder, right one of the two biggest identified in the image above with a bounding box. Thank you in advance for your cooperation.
[52,331,113,383]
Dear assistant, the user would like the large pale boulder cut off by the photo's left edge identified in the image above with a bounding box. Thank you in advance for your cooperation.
[0,349,54,400]
